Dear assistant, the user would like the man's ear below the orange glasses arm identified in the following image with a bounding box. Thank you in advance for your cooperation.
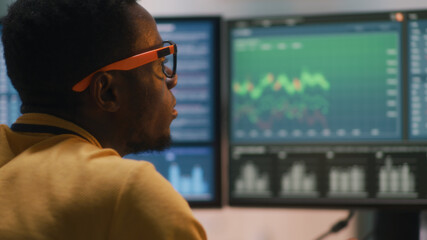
[89,72,120,112]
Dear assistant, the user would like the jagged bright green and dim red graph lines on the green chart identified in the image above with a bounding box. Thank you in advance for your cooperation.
[233,70,330,125]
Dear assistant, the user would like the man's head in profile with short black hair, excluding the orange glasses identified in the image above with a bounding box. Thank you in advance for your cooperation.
[3,0,176,155]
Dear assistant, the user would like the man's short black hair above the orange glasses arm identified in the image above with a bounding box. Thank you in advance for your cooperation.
[2,0,136,112]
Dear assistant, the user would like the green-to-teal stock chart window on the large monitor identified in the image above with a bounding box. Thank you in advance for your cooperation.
[231,32,401,142]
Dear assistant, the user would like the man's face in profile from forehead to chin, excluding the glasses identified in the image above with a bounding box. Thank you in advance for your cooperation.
[124,5,178,153]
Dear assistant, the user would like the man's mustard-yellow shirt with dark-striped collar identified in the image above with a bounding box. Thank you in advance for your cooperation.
[0,113,206,240]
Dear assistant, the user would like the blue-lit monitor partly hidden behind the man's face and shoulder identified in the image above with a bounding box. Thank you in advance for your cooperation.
[125,17,220,207]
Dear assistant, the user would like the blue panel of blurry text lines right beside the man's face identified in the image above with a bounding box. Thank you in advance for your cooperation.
[158,21,217,142]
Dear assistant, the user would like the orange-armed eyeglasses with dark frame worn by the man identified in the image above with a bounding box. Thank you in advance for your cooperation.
[72,41,178,92]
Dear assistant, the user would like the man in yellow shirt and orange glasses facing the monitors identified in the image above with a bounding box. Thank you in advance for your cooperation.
[0,0,206,240]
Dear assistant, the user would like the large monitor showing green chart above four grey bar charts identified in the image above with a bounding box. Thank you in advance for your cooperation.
[228,12,427,207]
